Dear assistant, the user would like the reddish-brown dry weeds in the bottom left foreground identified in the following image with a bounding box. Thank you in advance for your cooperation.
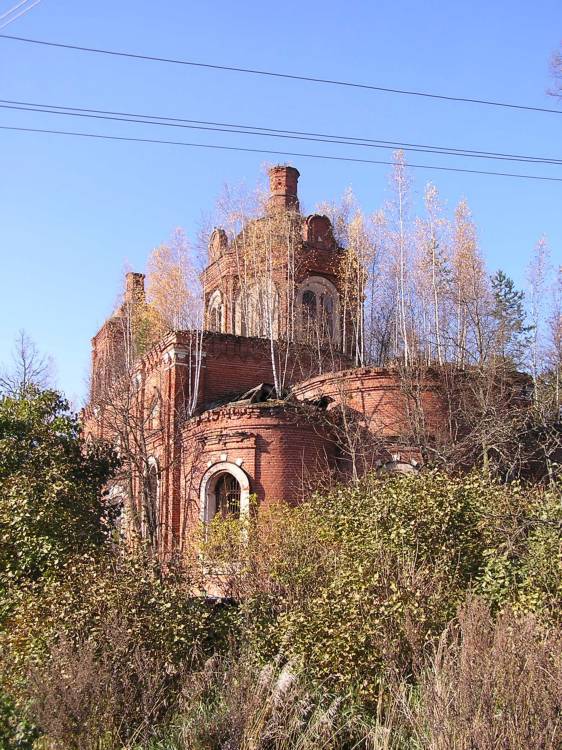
[29,621,179,750]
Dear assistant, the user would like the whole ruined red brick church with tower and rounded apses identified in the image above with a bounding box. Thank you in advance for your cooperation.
[83,166,443,550]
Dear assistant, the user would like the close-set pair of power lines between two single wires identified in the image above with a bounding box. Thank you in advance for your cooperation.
[0,99,562,165]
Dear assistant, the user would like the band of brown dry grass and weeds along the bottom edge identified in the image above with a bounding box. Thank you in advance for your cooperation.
[21,600,562,750]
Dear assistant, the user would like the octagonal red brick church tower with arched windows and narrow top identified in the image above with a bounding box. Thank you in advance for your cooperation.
[202,165,349,351]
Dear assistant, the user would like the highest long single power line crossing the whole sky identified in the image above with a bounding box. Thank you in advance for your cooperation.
[0,34,562,115]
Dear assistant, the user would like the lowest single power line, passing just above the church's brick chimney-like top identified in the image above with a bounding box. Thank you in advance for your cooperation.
[4,125,562,182]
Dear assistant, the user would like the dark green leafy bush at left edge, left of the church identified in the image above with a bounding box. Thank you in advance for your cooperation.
[0,388,116,604]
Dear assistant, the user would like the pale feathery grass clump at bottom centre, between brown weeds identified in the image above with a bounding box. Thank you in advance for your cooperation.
[159,652,380,750]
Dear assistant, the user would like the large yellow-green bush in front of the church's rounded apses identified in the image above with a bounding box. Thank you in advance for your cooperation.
[201,472,562,703]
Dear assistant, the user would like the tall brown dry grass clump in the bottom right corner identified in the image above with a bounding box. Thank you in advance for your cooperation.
[404,600,562,750]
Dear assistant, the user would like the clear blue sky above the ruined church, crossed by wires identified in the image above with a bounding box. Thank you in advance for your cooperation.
[0,0,562,401]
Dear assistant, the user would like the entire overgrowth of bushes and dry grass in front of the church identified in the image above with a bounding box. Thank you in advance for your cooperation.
[0,389,562,750]
